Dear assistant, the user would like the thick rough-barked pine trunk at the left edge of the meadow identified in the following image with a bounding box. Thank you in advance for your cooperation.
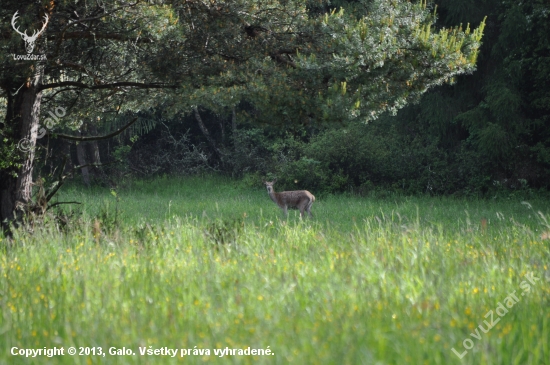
[0,64,44,233]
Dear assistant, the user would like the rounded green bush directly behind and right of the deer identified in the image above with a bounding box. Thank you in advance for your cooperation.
[270,121,448,193]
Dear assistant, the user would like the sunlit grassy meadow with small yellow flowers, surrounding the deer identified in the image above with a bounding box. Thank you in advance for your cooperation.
[0,177,550,365]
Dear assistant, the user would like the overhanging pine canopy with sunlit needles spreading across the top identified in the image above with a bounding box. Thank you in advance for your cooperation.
[0,0,484,128]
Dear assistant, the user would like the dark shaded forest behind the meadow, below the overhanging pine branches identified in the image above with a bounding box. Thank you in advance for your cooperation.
[39,0,550,196]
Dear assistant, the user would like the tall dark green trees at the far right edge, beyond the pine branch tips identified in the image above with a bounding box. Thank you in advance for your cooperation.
[455,1,550,187]
